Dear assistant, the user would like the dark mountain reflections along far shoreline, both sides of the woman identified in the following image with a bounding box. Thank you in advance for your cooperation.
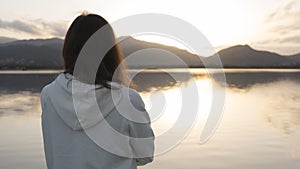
[0,69,300,93]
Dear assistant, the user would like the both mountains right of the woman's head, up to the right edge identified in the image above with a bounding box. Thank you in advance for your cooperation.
[120,37,300,68]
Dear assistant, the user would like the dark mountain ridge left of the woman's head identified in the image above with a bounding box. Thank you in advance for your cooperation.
[0,38,63,69]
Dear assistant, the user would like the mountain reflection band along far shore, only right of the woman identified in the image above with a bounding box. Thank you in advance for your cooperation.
[134,70,300,92]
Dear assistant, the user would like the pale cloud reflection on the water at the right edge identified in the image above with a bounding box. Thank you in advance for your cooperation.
[251,79,300,135]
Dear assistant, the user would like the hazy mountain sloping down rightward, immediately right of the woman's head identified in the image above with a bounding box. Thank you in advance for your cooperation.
[119,37,203,68]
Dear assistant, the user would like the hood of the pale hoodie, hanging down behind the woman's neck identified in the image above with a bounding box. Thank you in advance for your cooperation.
[49,73,122,130]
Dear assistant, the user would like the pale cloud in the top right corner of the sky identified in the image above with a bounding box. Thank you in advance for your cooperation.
[251,0,300,55]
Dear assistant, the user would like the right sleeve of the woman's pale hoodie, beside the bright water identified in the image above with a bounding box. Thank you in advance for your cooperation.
[129,91,154,165]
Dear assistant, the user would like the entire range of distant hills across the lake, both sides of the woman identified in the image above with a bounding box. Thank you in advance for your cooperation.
[0,37,300,70]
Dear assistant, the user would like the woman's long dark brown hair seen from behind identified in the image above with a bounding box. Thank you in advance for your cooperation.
[63,13,129,88]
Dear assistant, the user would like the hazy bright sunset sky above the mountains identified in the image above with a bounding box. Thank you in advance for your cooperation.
[0,0,300,54]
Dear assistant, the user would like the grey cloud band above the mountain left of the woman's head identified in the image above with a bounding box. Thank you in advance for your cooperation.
[0,19,67,37]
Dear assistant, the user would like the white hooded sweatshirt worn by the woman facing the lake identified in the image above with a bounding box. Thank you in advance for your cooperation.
[41,73,154,169]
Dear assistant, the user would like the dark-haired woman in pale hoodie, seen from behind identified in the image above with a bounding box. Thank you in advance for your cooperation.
[41,14,154,169]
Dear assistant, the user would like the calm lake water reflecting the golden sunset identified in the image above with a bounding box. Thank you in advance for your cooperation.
[0,70,300,169]
